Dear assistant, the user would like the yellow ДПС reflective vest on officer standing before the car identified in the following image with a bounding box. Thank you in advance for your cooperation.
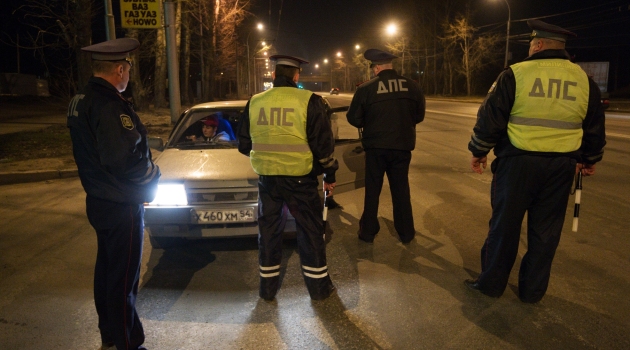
[248,87,313,176]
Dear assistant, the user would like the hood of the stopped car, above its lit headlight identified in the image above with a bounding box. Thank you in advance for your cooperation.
[155,149,258,183]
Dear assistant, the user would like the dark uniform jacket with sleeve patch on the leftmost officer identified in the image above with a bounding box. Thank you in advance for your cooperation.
[68,77,160,204]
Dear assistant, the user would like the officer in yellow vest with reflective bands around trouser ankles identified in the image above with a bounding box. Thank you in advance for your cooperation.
[238,55,339,301]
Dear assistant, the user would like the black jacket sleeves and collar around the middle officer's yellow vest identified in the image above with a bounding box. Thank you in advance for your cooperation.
[238,76,339,183]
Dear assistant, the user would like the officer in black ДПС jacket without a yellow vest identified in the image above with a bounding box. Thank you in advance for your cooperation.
[347,49,425,243]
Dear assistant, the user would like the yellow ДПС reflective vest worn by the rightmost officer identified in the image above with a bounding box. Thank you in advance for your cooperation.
[508,59,589,153]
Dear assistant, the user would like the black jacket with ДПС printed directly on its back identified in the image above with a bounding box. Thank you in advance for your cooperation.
[347,69,425,151]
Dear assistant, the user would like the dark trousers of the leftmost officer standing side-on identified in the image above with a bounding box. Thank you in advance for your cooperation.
[86,195,144,350]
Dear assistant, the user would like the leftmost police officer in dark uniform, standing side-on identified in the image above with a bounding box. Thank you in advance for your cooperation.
[68,38,160,350]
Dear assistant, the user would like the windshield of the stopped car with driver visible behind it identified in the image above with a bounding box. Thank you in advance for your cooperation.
[168,107,243,149]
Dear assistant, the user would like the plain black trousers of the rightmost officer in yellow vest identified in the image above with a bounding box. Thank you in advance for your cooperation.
[478,155,576,303]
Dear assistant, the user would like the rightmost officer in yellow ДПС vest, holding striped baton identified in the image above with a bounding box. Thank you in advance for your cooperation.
[465,20,606,303]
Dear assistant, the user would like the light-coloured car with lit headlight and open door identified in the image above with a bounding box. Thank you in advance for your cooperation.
[144,100,365,248]
